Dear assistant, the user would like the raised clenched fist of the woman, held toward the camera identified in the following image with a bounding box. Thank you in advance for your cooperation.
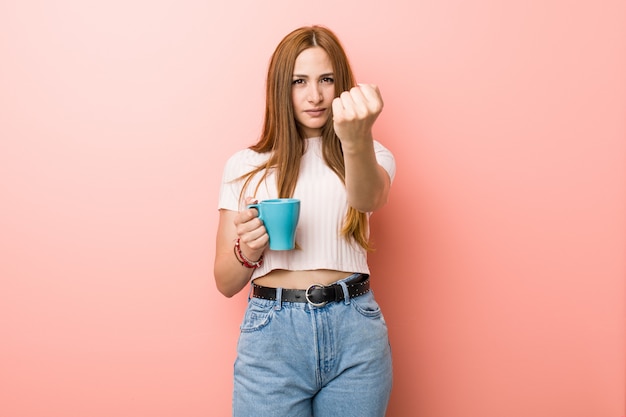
[333,84,383,148]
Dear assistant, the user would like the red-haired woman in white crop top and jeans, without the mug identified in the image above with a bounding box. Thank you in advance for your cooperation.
[214,26,395,417]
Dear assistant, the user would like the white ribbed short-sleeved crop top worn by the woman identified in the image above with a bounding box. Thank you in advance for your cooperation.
[218,137,396,279]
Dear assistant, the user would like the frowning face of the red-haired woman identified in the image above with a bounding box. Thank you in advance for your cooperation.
[291,47,335,138]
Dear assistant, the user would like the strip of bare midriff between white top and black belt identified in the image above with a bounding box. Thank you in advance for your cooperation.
[254,269,352,290]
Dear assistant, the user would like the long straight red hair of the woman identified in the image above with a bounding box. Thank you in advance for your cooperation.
[236,26,370,250]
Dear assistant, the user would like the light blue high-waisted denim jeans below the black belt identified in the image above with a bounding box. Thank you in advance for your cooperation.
[233,276,392,417]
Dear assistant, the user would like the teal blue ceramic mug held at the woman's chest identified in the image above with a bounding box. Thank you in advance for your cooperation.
[248,198,300,250]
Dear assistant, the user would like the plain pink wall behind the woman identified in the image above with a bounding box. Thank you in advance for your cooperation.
[0,0,626,417]
